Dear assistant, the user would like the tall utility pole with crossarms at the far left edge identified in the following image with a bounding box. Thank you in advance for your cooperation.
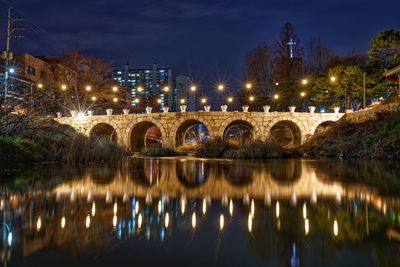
[2,7,25,99]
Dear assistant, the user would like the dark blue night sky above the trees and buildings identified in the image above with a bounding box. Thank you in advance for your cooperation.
[0,0,400,79]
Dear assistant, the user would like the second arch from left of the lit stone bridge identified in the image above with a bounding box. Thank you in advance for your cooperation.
[128,120,166,152]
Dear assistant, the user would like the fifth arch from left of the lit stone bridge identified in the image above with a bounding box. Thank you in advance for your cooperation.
[267,117,307,146]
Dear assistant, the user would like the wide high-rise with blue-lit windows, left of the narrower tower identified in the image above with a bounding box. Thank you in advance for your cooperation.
[113,63,174,110]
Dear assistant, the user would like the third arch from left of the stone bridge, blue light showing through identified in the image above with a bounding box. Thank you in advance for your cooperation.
[174,117,213,147]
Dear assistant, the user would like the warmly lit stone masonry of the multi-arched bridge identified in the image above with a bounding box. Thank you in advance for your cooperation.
[55,112,344,150]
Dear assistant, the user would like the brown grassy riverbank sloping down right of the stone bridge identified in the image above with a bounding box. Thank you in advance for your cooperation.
[300,112,400,160]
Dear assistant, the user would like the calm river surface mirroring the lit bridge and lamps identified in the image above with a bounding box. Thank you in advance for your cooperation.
[0,159,400,266]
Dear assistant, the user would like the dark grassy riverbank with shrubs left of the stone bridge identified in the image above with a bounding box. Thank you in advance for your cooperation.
[0,120,128,169]
